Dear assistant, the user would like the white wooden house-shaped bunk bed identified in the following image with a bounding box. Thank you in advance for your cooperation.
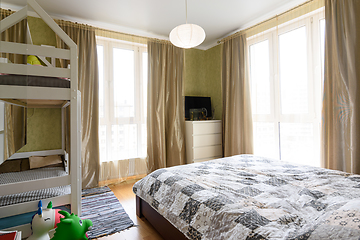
[0,0,81,237]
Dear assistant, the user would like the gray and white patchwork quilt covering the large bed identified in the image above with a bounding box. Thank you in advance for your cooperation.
[133,155,360,240]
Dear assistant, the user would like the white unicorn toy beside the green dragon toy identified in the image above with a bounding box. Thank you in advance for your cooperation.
[28,200,61,240]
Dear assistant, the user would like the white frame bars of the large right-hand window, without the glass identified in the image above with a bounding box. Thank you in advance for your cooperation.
[247,8,325,164]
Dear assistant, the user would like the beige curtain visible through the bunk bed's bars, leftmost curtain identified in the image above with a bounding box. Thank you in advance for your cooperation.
[0,9,27,160]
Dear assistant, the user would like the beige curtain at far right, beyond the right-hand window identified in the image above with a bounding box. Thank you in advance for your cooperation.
[322,0,360,174]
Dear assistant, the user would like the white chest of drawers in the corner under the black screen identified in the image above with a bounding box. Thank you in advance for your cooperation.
[185,120,222,163]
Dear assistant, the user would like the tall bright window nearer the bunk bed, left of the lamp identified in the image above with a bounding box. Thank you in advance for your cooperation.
[97,37,147,162]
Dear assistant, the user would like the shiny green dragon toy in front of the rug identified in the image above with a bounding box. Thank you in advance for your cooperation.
[51,211,92,240]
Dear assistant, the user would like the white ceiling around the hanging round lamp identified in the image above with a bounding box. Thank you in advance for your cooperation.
[0,0,307,49]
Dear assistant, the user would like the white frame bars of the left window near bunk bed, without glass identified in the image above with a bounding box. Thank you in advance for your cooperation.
[96,36,147,162]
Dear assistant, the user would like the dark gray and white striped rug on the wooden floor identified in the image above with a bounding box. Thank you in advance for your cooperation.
[81,187,134,239]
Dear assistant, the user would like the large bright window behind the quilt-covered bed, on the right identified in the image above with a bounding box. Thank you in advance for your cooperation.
[248,10,325,166]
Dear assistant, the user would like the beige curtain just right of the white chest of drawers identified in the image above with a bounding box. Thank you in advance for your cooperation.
[222,34,253,157]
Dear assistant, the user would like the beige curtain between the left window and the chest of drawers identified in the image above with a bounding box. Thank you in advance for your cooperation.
[147,41,186,173]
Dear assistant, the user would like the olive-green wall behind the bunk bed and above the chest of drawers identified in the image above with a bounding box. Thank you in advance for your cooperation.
[19,17,222,152]
